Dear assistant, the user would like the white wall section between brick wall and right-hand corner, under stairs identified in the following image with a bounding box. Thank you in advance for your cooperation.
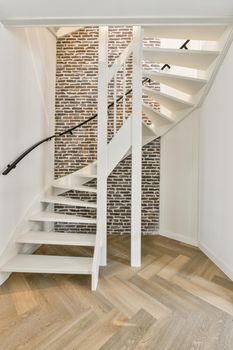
[159,110,199,245]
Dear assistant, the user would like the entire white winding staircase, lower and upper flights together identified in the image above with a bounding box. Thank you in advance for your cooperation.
[0,21,230,289]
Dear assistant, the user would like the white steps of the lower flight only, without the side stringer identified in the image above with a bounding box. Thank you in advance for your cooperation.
[0,175,97,275]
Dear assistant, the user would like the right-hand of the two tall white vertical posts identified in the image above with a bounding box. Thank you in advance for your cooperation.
[131,26,142,267]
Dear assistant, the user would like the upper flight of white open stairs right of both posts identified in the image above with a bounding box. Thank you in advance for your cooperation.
[142,25,232,136]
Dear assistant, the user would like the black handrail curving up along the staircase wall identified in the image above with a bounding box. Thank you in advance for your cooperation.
[2,40,190,175]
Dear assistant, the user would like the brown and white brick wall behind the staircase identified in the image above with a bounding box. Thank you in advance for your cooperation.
[55,27,160,234]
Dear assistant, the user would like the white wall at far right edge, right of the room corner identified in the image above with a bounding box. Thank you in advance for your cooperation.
[199,39,233,279]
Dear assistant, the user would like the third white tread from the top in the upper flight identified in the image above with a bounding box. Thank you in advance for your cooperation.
[143,70,207,94]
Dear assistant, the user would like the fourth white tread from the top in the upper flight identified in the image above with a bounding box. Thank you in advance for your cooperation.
[142,86,193,110]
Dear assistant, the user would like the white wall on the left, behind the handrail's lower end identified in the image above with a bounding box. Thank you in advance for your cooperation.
[0,28,56,262]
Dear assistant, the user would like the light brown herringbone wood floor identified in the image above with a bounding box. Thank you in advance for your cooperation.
[0,236,233,350]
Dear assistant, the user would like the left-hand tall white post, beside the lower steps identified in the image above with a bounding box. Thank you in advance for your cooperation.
[97,26,108,266]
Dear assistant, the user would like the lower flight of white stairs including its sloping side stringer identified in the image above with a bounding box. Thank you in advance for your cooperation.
[0,115,157,290]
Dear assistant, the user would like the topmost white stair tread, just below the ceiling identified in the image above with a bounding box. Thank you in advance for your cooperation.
[143,25,227,41]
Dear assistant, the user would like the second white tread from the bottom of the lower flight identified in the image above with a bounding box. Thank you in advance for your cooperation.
[17,231,96,247]
